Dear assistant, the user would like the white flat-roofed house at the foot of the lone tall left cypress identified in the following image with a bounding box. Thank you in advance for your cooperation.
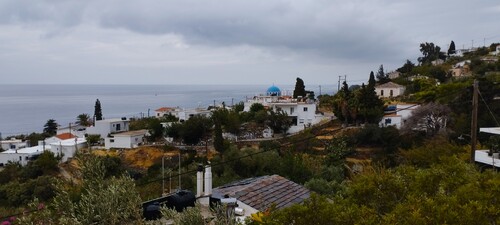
[87,117,130,138]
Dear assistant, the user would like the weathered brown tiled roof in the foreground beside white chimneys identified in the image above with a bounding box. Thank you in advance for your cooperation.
[213,175,310,211]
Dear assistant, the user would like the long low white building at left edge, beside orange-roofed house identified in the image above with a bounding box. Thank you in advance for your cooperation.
[0,145,46,167]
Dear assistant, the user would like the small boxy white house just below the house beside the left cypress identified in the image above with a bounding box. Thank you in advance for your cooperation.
[104,130,148,149]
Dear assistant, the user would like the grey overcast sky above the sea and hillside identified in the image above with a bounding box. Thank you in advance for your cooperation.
[0,0,500,86]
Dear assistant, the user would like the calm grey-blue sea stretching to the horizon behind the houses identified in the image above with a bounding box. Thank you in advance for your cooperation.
[0,85,336,135]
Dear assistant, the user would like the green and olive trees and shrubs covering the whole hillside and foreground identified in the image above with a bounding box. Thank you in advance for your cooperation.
[0,40,500,224]
